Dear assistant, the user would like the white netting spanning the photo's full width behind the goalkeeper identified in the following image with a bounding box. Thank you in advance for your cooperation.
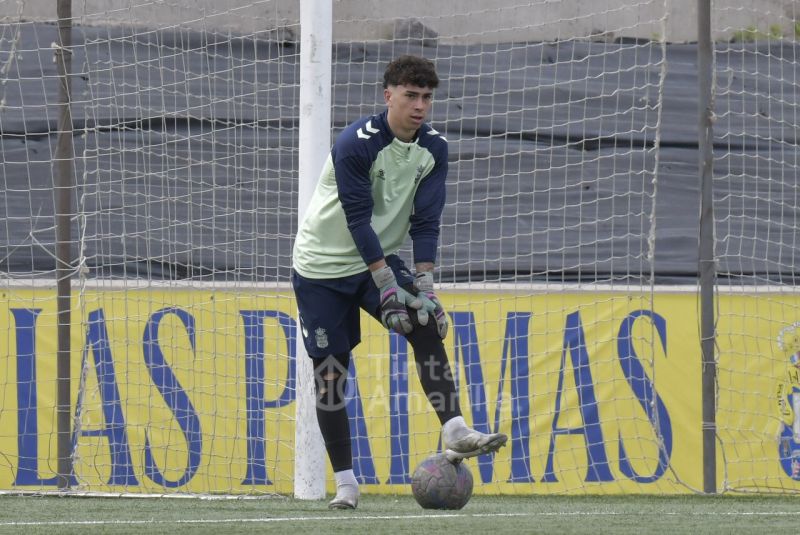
[6,0,784,495]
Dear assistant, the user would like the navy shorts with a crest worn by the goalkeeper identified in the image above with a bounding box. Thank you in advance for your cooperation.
[292,255,414,358]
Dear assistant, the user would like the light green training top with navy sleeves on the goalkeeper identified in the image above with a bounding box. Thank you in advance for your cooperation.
[293,111,447,279]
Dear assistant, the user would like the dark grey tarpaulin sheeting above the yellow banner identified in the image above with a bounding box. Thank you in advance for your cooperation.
[0,25,798,284]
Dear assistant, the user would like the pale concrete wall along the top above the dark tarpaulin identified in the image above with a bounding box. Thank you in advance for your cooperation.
[0,0,800,43]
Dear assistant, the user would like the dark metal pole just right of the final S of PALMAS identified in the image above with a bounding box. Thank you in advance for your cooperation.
[697,0,717,494]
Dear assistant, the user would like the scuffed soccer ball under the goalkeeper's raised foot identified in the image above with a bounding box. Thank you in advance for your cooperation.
[411,453,472,509]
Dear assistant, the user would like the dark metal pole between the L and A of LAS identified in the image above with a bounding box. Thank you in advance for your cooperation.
[53,0,75,489]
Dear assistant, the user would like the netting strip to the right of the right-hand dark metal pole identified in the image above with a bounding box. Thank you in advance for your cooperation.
[713,1,800,492]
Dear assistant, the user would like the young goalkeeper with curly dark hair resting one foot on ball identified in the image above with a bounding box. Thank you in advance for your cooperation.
[292,56,507,509]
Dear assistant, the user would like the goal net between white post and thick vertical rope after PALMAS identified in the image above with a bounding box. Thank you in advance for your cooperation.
[332,2,685,494]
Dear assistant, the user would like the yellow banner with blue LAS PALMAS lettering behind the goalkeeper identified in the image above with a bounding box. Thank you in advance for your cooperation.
[0,288,800,494]
